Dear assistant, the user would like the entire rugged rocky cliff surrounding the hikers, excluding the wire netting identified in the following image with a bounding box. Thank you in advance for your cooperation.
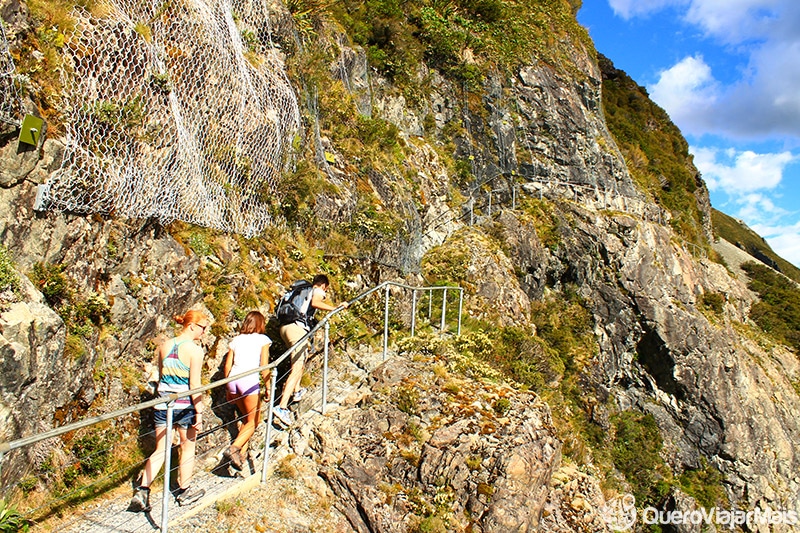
[0,0,800,531]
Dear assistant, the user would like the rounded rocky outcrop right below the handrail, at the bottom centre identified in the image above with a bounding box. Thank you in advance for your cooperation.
[307,358,561,532]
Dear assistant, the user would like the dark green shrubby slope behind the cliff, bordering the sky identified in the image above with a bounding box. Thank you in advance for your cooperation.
[599,56,707,248]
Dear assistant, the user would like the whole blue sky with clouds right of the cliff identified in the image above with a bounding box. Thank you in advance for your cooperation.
[578,0,800,266]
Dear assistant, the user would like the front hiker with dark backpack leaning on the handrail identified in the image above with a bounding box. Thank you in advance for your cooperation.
[273,274,349,427]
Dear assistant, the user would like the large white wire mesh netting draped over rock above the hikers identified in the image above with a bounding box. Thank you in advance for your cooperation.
[43,0,300,236]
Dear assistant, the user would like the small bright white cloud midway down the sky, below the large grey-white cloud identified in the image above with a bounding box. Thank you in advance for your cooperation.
[691,147,797,193]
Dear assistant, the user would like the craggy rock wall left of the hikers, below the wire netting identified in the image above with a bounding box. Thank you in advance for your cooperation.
[0,178,209,480]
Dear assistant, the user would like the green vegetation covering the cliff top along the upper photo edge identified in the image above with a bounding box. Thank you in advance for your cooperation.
[328,0,594,103]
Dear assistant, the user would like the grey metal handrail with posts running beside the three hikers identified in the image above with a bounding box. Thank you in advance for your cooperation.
[0,281,464,531]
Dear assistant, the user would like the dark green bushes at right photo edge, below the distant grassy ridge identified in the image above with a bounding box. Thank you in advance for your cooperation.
[742,263,800,354]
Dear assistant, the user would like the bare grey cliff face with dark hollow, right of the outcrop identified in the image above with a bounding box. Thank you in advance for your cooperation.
[488,198,800,509]
